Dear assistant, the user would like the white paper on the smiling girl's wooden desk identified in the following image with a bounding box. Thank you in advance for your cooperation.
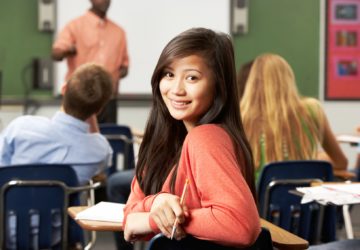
[75,201,125,223]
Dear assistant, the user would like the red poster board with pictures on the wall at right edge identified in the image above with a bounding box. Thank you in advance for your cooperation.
[325,0,360,100]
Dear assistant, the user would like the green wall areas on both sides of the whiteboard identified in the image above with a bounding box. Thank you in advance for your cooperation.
[0,0,319,99]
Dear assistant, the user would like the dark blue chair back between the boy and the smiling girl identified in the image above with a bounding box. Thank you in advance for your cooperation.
[99,123,135,175]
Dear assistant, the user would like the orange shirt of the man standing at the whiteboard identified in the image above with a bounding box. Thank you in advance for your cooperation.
[53,11,129,93]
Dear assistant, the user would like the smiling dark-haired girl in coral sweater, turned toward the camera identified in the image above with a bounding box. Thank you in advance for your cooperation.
[123,28,260,247]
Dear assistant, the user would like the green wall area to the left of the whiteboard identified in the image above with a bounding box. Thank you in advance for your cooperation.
[0,0,52,99]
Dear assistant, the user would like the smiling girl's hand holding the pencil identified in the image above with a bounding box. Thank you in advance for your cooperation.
[150,193,188,240]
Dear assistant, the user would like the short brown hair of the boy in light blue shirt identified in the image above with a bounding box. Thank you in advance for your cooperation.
[63,64,113,121]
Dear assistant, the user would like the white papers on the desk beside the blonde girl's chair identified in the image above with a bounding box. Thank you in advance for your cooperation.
[296,184,360,205]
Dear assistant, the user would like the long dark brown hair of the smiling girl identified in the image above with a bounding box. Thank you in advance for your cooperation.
[136,28,255,197]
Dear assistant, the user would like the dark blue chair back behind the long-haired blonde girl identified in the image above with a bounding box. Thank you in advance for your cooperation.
[258,160,336,244]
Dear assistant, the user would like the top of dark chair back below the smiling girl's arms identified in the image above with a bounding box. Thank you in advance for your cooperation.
[147,228,273,250]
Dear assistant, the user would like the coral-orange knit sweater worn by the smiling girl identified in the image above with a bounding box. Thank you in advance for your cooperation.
[124,124,260,247]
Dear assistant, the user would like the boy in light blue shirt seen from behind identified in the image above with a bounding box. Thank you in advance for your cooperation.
[0,64,113,184]
